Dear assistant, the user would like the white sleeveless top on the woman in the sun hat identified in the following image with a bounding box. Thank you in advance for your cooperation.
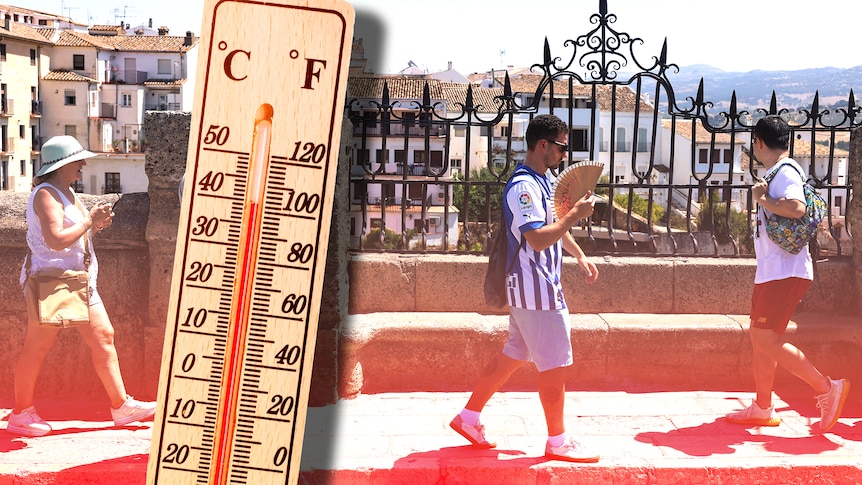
[20,182,99,289]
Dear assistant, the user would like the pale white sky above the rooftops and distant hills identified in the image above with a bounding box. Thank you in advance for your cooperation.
[27,0,862,75]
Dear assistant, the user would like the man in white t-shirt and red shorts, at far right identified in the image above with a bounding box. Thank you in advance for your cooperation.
[726,115,850,431]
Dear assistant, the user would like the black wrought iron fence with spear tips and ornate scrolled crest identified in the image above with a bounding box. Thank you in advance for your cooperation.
[347,0,862,257]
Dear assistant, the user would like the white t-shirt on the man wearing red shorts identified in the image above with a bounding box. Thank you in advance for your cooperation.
[754,158,814,284]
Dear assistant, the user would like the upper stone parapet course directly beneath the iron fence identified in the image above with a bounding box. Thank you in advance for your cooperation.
[349,254,857,314]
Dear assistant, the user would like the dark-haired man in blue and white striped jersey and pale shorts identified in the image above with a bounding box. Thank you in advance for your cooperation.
[450,115,599,463]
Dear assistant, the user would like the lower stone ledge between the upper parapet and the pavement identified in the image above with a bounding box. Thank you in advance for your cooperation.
[340,312,862,397]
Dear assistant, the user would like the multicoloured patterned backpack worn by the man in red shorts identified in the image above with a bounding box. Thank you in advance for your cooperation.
[766,163,829,254]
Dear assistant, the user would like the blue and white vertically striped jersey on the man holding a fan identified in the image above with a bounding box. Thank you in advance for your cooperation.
[503,165,566,310]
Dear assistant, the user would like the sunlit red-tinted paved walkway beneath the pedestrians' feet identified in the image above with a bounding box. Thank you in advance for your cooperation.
[0,390,862,485]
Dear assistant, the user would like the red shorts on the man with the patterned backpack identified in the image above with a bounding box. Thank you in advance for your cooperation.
[750,278,811,334]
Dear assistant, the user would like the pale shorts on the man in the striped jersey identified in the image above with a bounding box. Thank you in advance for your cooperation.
[503,307,574,372]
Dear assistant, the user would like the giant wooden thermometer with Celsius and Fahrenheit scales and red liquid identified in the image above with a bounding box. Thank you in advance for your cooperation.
[147,0,354,485]
